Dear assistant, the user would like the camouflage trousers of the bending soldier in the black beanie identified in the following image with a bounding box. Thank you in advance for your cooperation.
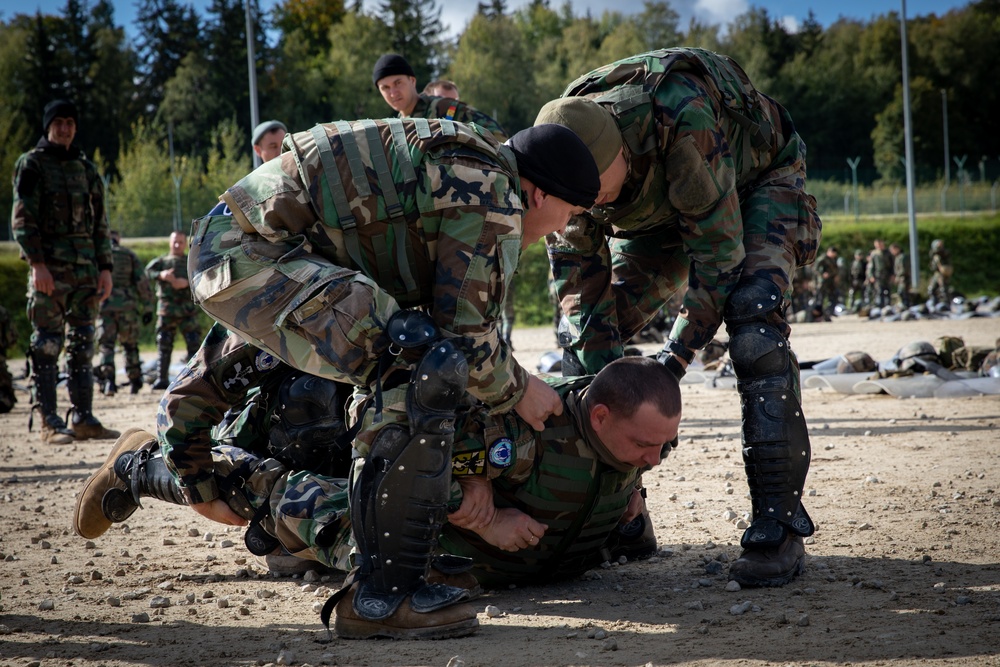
[188,215,400,387]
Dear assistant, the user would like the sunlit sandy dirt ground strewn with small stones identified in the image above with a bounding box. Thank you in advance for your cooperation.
[0,318,1000,667]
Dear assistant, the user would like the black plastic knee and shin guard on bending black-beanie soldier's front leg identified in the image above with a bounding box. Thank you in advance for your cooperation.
[350,340,469,624]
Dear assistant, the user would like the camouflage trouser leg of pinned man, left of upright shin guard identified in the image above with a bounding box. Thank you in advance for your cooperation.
[212,445,354,572]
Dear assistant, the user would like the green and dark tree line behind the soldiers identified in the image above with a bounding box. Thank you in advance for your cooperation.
[0,0,1000,236]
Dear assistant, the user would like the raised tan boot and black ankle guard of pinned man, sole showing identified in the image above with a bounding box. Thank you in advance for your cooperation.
[73,428,187,540]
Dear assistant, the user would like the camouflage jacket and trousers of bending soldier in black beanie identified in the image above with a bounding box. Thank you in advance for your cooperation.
[190,119,528,434]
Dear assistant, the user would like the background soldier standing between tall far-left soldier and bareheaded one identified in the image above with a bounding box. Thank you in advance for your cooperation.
[97,231,153,396]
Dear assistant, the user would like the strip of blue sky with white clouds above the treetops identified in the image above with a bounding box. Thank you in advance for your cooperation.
[7,0,969,35]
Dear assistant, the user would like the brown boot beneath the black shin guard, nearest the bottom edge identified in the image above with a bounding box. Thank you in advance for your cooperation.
[333,584,479,639]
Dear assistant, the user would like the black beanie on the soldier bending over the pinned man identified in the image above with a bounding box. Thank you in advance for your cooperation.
[507,123,601,208]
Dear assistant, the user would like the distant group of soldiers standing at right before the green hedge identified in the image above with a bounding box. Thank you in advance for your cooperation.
[788,239,953,322]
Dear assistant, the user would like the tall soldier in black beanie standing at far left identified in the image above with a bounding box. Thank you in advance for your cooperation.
[11,100,118,444]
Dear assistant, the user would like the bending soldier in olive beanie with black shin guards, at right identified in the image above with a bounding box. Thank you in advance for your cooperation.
[536,48,821,586]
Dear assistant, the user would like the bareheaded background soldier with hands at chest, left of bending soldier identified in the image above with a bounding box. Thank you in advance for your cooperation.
[146,231,201,391]
